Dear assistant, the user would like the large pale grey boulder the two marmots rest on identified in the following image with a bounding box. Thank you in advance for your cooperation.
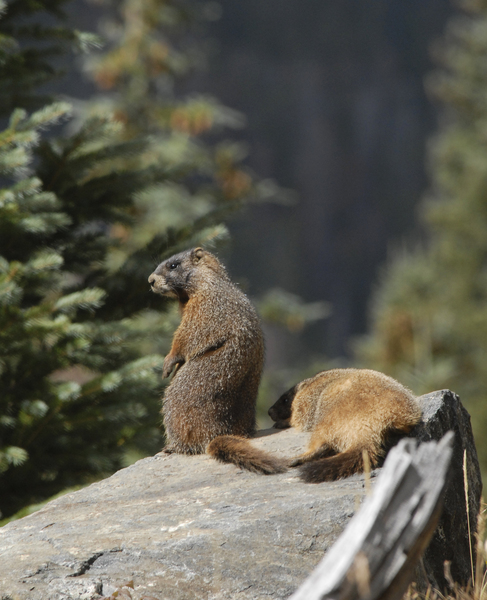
[0,392,481,600]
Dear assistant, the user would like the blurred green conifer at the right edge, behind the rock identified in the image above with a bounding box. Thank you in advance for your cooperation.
[359,0,487,471]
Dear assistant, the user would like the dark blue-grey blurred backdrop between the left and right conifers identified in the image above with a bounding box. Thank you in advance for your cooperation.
[197,0,452,364]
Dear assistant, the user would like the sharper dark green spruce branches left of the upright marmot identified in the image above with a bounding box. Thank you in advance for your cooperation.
[0,98,169,514]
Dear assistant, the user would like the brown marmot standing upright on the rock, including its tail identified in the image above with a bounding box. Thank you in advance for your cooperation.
[149,248,286,474]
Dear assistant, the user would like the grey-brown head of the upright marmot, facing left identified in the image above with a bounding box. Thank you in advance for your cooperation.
[149,248,228,302]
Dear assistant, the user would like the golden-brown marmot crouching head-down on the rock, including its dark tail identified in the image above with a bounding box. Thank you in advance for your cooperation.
[269,369,421,483]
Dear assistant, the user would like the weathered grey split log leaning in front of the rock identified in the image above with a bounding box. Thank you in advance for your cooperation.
[289,432,454,600]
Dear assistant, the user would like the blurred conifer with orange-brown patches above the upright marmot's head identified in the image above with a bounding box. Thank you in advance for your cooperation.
[82,0,276,270]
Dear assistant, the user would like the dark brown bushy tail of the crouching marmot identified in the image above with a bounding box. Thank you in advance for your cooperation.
[299,448,377,483]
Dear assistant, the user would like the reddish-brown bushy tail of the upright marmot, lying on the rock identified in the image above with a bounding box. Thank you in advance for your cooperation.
[206,435,287,475]
